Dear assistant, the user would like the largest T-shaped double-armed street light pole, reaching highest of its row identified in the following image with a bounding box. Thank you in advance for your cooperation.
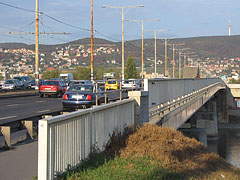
[102,5,144,80]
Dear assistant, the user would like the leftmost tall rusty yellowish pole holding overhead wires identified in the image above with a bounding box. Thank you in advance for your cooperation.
[35,0,39,89]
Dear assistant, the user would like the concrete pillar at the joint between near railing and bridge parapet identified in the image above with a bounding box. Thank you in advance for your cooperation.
[128,91,149,125]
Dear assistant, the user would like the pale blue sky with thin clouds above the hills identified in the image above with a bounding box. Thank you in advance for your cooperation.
[0,0,240,44]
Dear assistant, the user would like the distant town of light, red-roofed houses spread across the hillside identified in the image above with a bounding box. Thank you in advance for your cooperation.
[0,42,240,79]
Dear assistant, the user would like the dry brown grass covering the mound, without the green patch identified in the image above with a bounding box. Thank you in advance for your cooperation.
[120,125,240,179]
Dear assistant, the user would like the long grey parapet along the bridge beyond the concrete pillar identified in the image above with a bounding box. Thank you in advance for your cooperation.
[144,78,225,107]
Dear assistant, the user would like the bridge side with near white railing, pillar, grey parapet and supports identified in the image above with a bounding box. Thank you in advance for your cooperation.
[38,79,227,180]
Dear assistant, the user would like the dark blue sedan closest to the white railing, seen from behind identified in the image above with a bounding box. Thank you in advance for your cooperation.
[62,84,105,109]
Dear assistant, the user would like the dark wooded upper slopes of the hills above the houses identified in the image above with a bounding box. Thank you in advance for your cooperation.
[0,35,240,60]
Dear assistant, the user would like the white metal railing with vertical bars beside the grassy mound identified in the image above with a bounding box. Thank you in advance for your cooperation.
[38,98,135,180]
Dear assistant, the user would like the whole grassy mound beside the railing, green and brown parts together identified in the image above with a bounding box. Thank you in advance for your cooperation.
[58,125,240,180]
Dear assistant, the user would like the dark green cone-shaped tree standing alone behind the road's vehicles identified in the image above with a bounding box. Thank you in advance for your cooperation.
[125,56,139,79]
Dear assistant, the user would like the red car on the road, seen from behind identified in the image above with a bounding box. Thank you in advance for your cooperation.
[39,80,66,97]
